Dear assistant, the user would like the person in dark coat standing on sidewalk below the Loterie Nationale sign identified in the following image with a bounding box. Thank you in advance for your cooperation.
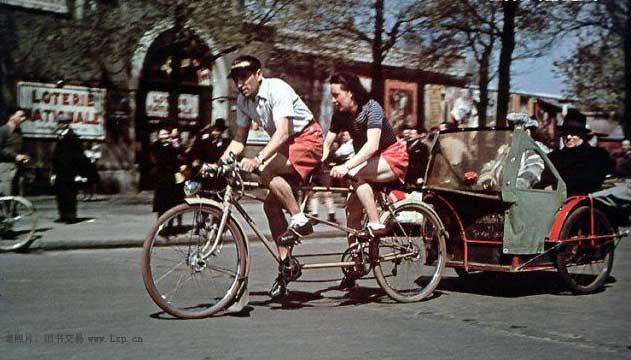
[52,113,85,224]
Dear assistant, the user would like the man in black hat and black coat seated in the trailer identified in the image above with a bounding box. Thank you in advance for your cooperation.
[548,109,611,196]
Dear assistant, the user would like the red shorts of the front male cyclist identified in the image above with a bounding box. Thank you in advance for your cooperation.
[278,121,324,181]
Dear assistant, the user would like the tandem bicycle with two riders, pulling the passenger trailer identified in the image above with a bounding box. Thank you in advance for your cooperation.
[142,159,446,318]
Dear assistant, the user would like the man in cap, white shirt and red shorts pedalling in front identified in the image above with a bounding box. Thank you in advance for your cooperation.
[222,55,323,297]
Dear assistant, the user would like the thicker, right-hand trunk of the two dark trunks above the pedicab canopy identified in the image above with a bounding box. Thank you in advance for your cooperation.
[495,1,518,126]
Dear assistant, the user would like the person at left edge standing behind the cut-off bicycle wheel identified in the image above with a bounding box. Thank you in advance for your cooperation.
[0,108,30,195]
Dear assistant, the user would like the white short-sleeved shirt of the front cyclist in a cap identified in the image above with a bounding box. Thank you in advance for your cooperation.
[236,78,313,136]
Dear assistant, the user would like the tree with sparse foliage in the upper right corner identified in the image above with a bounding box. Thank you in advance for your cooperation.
[556,0,631,138]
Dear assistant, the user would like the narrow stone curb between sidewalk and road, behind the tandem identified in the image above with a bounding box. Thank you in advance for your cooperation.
[28,231,344,253]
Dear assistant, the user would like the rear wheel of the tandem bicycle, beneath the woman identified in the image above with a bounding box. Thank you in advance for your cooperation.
[371,204,446,302]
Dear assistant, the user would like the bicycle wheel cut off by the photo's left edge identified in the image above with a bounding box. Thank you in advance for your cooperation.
[0,196,37,251]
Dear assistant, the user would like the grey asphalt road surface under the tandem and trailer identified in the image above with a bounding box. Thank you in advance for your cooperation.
[0,238,631,360]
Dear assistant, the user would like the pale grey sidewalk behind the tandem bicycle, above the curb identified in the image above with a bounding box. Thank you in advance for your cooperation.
[29,192,345,250]
